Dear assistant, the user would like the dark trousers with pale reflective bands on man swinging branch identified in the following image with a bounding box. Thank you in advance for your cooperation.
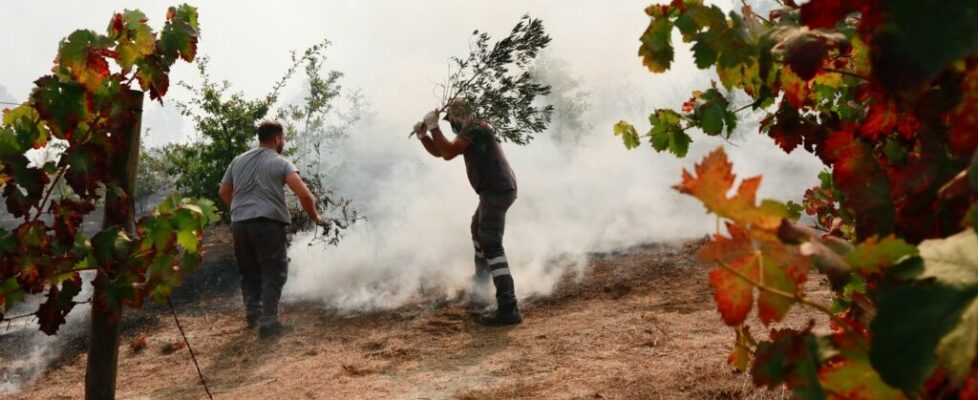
[472,190,516,310]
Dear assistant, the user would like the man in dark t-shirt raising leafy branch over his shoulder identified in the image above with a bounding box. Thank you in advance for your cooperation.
[414,100,523,325]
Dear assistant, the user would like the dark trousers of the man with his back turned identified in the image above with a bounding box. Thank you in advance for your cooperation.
[231,218,289,326]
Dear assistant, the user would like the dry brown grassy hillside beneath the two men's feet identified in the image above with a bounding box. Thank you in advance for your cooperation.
[0,228,828,400]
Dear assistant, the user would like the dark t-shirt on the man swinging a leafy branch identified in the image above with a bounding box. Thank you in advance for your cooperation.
[458,122,516,194]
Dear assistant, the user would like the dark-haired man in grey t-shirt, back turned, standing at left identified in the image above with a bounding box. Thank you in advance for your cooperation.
[218,121,321,337]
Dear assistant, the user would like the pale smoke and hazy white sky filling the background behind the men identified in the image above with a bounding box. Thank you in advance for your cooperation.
[0,0,820,394]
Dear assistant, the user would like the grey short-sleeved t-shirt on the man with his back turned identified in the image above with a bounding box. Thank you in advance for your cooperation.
[221,147,299,224]
